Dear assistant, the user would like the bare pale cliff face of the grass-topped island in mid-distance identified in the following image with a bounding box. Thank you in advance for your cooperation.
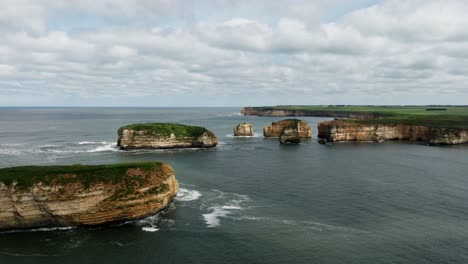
[117,128,218,149]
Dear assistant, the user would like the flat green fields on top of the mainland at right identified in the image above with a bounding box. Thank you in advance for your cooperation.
[247,105,468,129]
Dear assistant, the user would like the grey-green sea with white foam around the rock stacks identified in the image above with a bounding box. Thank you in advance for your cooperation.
[0,108,468,264]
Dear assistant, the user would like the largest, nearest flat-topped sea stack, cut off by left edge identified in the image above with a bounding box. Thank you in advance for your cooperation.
[0,162,178,229]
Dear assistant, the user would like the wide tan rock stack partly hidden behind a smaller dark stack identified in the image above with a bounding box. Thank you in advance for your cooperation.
[263,119,312,138]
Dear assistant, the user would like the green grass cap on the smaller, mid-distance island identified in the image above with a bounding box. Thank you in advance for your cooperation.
[120,123,208,138]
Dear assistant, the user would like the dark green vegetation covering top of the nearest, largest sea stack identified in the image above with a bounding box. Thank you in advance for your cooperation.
[0,162,162,188]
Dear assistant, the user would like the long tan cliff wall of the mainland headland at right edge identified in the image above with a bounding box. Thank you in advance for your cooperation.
[318,120,468,145]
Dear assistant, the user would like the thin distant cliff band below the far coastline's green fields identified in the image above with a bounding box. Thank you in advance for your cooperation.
[241,107,383,119]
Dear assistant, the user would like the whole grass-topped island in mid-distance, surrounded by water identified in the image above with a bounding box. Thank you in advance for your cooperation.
[117,123,218,150]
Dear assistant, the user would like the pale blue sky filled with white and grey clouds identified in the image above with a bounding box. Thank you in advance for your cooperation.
[0,0,468,107]
